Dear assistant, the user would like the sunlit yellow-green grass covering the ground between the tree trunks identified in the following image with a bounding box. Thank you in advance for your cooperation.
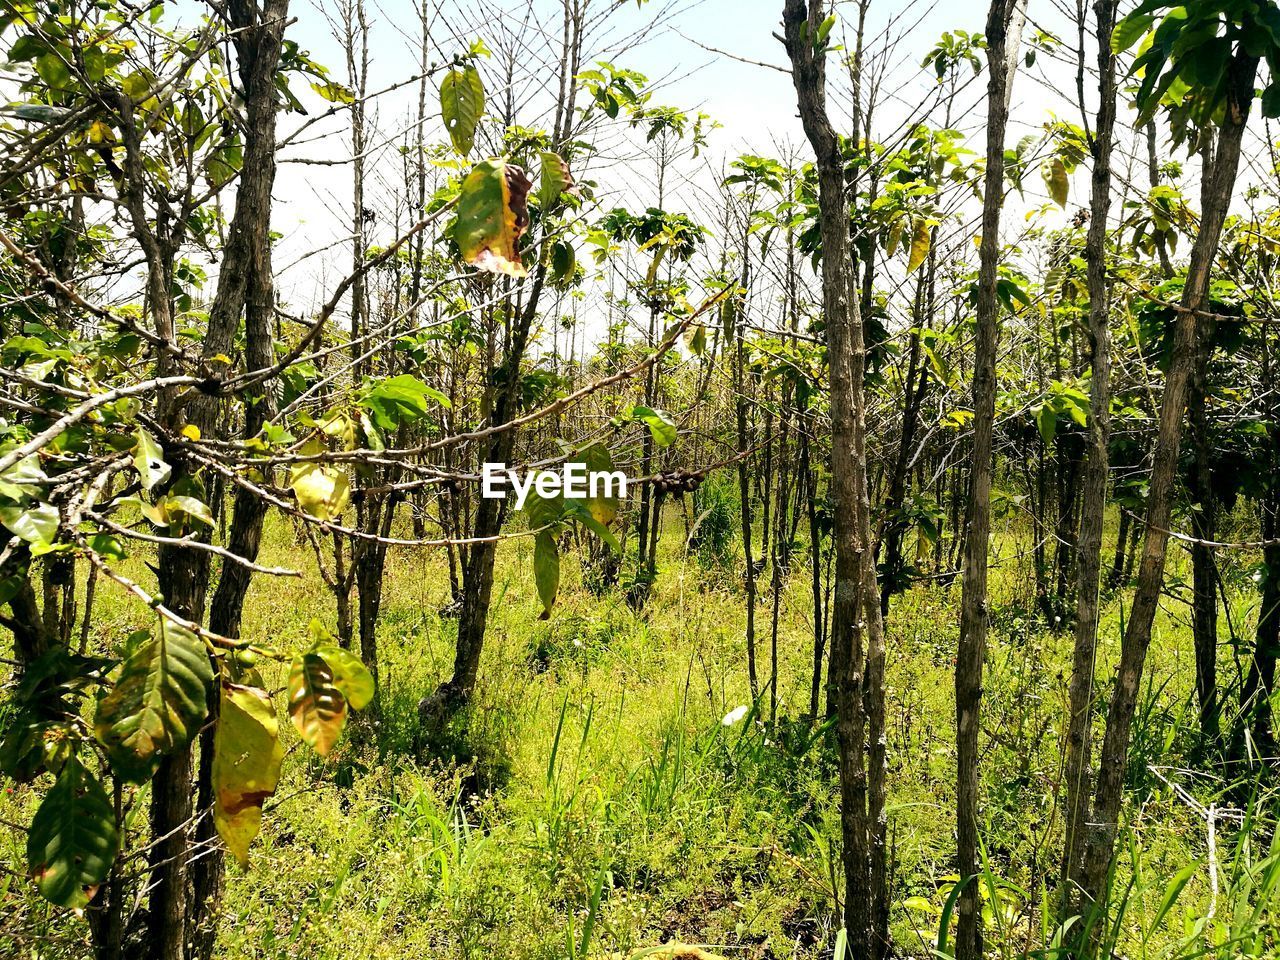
[0,496,1265,960]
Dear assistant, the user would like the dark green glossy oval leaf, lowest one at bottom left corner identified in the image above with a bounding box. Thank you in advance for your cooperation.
[27,756,119,909]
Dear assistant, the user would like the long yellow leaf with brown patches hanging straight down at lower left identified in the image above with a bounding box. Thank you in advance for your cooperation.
[212,684,284,868]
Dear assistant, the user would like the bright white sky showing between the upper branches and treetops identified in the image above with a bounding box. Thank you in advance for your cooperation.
[247,0,1092,316]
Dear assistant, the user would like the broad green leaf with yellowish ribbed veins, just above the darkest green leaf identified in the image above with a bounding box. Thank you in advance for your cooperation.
[93,618,214,783]
